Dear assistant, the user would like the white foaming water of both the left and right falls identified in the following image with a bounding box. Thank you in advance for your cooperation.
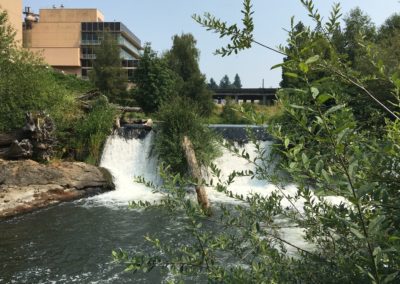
[91,132,307,250]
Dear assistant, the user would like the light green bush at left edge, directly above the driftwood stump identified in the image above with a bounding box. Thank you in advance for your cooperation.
[0,11,77,131]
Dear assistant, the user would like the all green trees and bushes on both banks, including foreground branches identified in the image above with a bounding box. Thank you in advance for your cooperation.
[0,0,400,283]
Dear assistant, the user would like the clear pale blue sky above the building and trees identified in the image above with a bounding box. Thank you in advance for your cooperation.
[23,0,400,87]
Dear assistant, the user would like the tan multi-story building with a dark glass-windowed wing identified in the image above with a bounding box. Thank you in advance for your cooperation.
[23,7,142,79]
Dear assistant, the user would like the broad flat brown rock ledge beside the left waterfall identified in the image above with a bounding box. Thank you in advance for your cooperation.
[0,159,114,218]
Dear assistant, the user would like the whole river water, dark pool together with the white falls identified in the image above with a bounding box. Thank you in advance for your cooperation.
[0,130,306,283]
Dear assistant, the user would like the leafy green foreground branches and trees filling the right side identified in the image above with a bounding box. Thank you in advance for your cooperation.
[113,0,400,283]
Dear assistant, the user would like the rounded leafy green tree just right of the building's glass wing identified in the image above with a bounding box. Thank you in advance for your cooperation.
[133,44,180,112]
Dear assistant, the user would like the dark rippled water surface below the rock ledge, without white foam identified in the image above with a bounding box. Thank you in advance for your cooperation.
[0,201,179,283]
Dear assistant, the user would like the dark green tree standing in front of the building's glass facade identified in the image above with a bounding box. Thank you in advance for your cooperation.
[89,31,127,101]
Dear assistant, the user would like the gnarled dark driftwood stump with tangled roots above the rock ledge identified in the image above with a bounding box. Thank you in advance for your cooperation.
[0,112,56,161]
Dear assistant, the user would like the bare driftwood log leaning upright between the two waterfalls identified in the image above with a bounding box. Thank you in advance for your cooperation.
[182,136,211,214]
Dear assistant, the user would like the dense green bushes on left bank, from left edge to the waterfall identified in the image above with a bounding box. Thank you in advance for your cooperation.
[0,11,115,162]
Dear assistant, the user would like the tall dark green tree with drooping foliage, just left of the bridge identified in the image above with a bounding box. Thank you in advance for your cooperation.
[165,34,213,116]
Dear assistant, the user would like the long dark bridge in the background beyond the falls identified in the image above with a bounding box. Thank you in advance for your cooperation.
[213,88,278,105]
